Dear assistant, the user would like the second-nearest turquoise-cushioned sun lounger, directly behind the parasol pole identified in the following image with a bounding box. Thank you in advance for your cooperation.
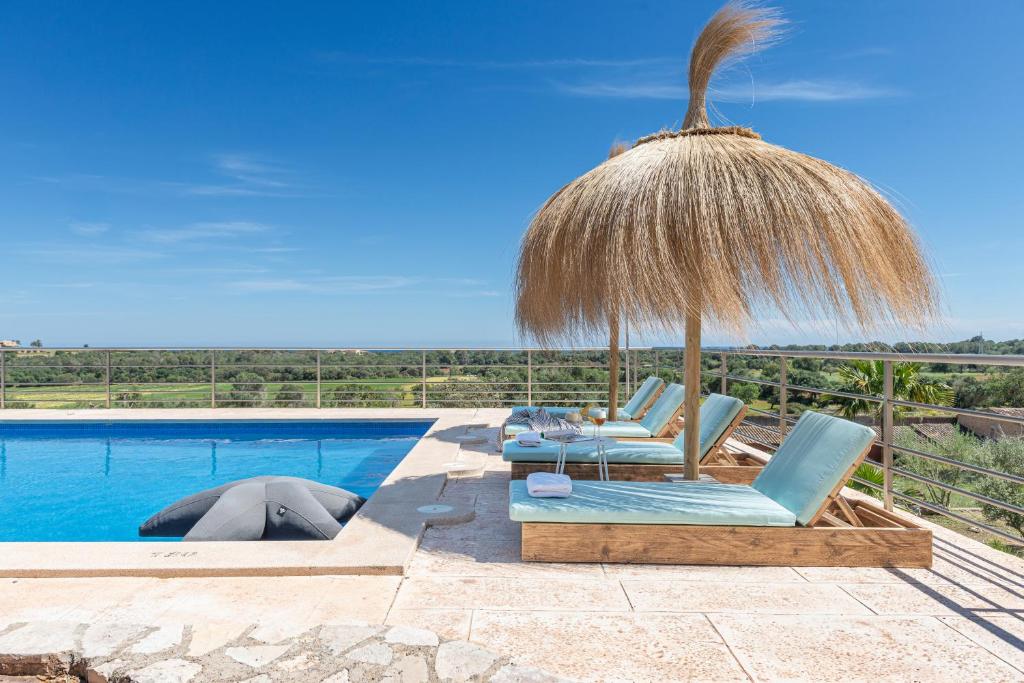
[502,393,764,483]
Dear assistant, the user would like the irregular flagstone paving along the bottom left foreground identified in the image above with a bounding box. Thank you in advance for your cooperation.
[0,622,561,683]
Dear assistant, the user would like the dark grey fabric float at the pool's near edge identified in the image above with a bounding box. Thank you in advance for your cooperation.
[138,476,366,541]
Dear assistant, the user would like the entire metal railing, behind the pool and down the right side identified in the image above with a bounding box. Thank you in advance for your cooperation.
[6,347,1024,544]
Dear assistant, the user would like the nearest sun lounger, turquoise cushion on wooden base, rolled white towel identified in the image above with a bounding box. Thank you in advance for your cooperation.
[509,411,932,567]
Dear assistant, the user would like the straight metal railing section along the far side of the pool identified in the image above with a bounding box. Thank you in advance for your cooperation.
[0,348,655,409]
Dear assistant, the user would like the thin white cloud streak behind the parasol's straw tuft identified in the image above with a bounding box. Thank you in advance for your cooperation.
[554,79,899,102]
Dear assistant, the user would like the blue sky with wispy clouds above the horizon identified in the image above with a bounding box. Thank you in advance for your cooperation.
[0,0,1024,346]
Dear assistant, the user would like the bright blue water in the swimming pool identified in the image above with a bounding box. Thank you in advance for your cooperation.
[0,421,431,540]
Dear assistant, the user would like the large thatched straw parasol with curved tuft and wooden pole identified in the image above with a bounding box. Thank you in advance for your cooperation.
[516,3,938,478]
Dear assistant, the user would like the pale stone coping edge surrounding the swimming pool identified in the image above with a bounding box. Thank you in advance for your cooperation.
[0,409,476,579]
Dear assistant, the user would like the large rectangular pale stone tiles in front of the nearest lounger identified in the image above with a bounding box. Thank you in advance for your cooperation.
[390,440,1024,683]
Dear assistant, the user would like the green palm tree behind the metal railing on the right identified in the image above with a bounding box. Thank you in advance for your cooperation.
[837,360,954,419]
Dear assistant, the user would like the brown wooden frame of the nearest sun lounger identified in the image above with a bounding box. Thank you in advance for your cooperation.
[522,446,932,567]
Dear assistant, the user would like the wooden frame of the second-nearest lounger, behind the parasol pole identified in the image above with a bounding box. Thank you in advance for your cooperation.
[512,405,765,484]
